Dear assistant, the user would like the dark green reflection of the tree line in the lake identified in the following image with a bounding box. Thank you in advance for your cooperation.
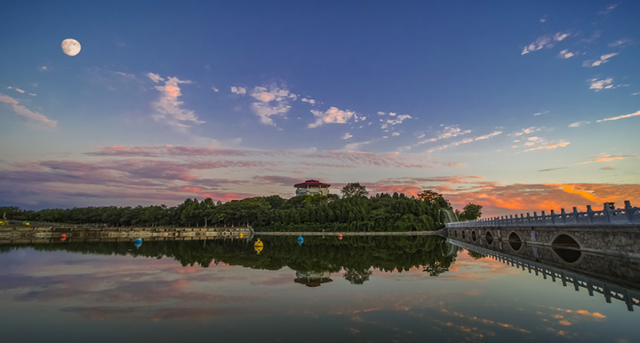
[0,236,458,284]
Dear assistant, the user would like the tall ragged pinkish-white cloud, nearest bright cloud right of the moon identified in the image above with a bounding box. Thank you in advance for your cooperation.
[147,73,204,131]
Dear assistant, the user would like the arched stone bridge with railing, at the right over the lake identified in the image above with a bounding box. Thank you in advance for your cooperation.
[445,201,640,259]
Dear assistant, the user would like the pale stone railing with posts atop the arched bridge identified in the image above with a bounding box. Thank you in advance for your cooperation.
[445,200,640,227]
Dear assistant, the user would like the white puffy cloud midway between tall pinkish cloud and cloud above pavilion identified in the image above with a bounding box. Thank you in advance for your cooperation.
[249,85,297,125]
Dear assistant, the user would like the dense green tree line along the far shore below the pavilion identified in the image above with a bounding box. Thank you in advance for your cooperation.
[0,183,482,231]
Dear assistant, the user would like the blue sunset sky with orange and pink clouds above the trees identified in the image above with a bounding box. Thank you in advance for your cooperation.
[0,1,640,217]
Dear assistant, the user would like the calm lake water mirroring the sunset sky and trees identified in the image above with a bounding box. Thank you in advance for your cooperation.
[0,236,640,342]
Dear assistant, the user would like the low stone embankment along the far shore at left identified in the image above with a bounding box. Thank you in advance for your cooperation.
[0,226,251,244]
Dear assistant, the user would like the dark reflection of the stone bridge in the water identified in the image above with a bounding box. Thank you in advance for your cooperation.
[447,238,640,311]
